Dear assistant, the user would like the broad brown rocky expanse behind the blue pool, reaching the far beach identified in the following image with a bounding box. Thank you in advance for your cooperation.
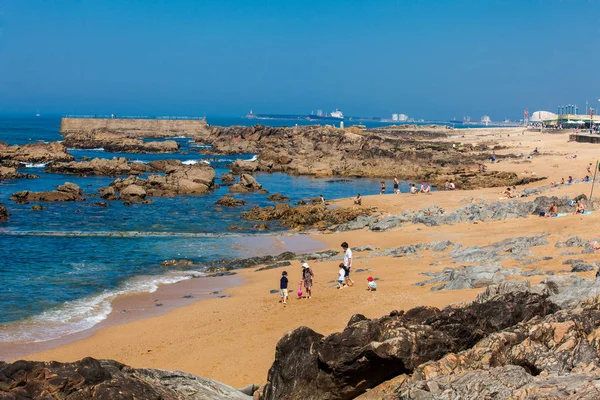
[196,125,543,189]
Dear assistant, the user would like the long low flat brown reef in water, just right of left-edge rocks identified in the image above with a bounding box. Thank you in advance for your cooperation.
[46,157,150,176]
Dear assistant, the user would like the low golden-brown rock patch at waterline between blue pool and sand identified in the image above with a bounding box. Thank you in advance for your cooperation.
[242,204,375,230]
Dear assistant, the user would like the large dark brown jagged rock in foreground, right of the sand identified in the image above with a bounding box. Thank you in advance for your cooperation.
[256,292,557,400]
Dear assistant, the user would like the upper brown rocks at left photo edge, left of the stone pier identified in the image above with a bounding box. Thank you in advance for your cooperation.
[0,142,73,166]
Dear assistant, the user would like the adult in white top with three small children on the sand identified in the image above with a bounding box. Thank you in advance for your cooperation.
[279,242,377,304]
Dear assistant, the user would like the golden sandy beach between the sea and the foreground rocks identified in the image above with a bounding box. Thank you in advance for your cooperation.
[14,128,600,387]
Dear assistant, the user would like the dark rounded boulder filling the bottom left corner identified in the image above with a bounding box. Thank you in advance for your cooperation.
[0,357,252,400]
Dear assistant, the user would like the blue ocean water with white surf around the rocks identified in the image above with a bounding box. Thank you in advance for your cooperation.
[0,117,434,342]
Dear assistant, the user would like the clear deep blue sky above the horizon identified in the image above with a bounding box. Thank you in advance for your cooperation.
[0,0,600,120]
